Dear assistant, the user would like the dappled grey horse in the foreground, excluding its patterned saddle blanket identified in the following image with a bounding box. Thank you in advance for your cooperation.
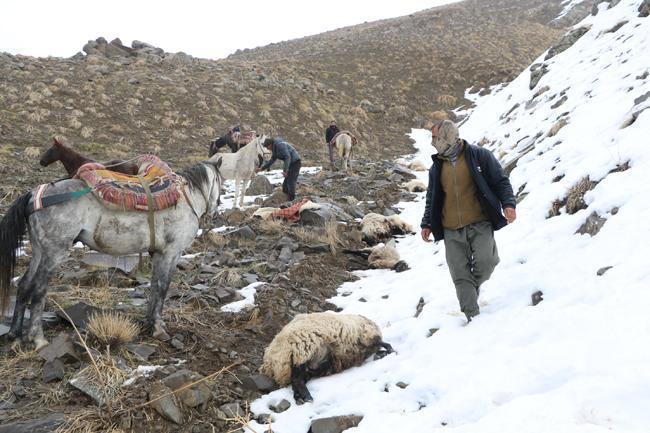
[0,160,222,348]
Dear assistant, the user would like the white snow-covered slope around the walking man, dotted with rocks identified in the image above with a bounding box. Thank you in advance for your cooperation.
[246,0,650,433]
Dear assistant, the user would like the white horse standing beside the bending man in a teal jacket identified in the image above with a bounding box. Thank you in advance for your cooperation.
[210,136,271,208]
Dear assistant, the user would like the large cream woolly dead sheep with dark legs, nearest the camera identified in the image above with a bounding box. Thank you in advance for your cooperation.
[260,313,393,404]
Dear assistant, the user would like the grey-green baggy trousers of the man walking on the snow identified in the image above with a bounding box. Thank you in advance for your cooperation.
[445,221,499,320]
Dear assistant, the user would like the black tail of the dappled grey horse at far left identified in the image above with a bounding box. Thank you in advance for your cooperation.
[0,191,32,316]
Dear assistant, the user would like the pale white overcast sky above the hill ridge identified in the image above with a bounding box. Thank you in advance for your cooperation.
[0,0,458,58]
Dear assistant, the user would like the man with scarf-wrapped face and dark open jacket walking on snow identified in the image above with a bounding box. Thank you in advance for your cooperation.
[420,120,517,321]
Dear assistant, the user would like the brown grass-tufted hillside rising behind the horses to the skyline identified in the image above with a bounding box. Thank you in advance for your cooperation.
[0,0,584,211]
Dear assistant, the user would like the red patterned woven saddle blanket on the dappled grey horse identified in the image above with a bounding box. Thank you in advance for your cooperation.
[74,155,181,212]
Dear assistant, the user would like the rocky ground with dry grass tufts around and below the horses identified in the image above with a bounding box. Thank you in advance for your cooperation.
[0,161,422,433]
